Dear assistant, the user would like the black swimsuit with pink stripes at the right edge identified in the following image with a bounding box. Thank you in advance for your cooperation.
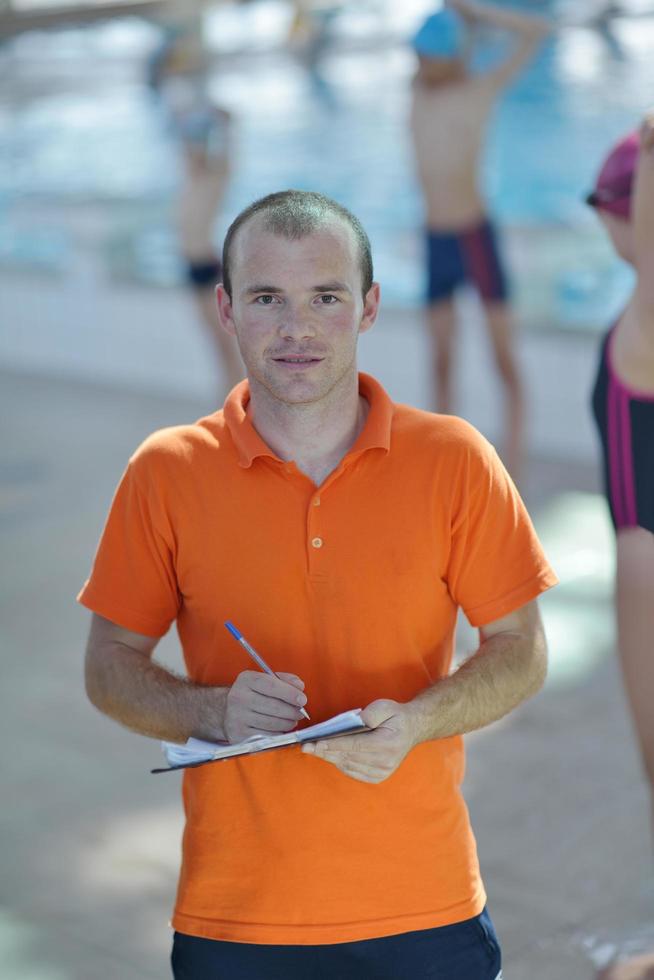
[593,327,654,533]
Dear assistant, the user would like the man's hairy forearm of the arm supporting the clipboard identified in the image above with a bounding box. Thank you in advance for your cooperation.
[406,630,547,745]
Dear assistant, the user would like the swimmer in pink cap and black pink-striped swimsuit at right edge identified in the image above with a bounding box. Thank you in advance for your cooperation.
[588,111,654,980]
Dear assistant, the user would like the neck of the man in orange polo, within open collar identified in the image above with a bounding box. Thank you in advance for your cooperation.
[248,374,369,486]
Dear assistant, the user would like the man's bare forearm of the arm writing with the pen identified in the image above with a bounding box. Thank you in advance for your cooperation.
[86,643,229,742]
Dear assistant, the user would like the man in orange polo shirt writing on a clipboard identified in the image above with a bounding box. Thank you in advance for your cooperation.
[80,191,556,980]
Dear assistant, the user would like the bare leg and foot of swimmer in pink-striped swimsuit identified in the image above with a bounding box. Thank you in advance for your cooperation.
[598,527,654,980]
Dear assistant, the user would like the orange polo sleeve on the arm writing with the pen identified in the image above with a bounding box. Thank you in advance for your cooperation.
[77,455,180,636]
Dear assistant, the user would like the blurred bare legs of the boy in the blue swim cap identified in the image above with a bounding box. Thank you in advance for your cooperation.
[428,299,524,483]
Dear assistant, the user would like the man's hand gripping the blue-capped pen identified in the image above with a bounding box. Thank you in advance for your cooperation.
[223,670,307,743]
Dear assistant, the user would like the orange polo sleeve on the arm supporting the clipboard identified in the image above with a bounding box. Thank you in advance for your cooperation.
[447,430,557,626]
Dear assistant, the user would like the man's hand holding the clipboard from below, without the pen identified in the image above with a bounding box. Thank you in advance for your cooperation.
[302,700,416,783]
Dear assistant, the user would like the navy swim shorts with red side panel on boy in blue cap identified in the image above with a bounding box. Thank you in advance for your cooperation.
[427,221,509,303]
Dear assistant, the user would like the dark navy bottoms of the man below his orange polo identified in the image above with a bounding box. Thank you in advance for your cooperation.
[171,911,502,980]
